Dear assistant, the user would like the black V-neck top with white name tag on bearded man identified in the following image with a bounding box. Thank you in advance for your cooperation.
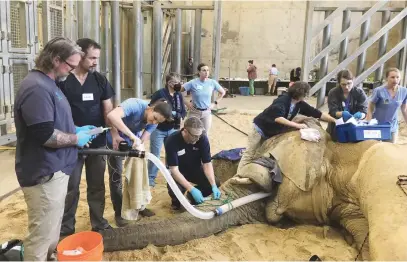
[58,72,114,148]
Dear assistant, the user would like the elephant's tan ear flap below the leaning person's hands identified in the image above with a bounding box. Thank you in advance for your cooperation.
[258,119,329,191]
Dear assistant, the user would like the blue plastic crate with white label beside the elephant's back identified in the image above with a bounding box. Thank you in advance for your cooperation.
[336,123,391,143]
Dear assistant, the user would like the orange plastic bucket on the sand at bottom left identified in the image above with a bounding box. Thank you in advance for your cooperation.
[57,231,104,261]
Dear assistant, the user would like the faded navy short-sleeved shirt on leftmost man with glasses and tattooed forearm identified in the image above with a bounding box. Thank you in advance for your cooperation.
[14,70,78,187]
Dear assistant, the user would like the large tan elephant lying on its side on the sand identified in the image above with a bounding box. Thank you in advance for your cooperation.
[102,118,407,260]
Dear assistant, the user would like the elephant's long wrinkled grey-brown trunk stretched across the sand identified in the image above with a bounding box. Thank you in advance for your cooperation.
[102,209,249,252]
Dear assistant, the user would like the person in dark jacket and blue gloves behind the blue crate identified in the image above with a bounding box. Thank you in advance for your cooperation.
[326,69,367,141]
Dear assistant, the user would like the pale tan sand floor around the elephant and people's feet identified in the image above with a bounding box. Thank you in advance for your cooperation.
[0,99,407,260]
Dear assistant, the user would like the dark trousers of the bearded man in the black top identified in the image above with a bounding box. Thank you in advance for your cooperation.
[61,152,109,235]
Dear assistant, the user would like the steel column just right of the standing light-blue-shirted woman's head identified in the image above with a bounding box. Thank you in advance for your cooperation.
[212,0,222,81]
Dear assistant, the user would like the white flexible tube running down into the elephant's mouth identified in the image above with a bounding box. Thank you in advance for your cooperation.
[146,153,271,219]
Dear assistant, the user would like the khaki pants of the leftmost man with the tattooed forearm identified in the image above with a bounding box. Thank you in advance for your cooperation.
[22,171,69,261]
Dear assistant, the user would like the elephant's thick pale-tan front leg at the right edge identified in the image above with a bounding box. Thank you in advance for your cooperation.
[356,144,407,260]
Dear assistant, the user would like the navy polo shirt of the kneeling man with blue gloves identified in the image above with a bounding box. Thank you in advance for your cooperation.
[165,131,211,178]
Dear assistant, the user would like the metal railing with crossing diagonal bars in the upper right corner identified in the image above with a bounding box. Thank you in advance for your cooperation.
[301,0,407,108]
